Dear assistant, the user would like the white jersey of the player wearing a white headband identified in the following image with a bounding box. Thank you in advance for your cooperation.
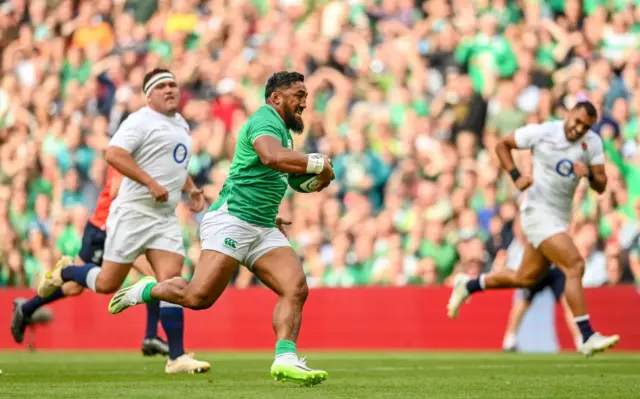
[109,107,191,214]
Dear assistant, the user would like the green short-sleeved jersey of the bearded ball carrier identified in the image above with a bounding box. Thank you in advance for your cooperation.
[209,105,293,227]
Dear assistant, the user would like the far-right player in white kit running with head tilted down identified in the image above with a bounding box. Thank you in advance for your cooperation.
[447,102,620,356]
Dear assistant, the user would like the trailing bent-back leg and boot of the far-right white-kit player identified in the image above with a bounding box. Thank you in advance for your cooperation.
[447,243,550,319]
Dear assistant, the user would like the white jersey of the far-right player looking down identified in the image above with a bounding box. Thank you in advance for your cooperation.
[514,121,604,220]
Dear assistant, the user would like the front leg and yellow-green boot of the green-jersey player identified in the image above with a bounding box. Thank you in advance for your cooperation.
[252,247,328,385]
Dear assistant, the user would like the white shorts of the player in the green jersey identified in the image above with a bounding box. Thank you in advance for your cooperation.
[200,211,291,269]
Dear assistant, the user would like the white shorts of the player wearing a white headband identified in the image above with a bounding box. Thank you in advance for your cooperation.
[104,207,185,264]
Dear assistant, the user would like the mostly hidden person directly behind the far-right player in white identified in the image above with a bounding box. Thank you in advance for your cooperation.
[492,215,582,352]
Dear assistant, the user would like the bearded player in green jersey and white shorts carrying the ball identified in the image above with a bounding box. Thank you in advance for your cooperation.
[109,72,334,385]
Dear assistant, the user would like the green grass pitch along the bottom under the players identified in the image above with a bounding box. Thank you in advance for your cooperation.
[0,352,640,399]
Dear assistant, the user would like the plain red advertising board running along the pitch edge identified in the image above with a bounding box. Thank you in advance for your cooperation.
[0,286,640,350]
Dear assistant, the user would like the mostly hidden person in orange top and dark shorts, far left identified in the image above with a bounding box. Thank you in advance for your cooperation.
[11,167,169,356]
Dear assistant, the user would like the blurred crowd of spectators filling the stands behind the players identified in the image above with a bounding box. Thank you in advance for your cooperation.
[0,0,640,287]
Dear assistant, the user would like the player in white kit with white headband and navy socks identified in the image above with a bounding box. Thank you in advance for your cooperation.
[38,69,210,373]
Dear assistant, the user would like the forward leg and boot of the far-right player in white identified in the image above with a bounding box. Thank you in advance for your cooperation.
[538,233,620,356]
